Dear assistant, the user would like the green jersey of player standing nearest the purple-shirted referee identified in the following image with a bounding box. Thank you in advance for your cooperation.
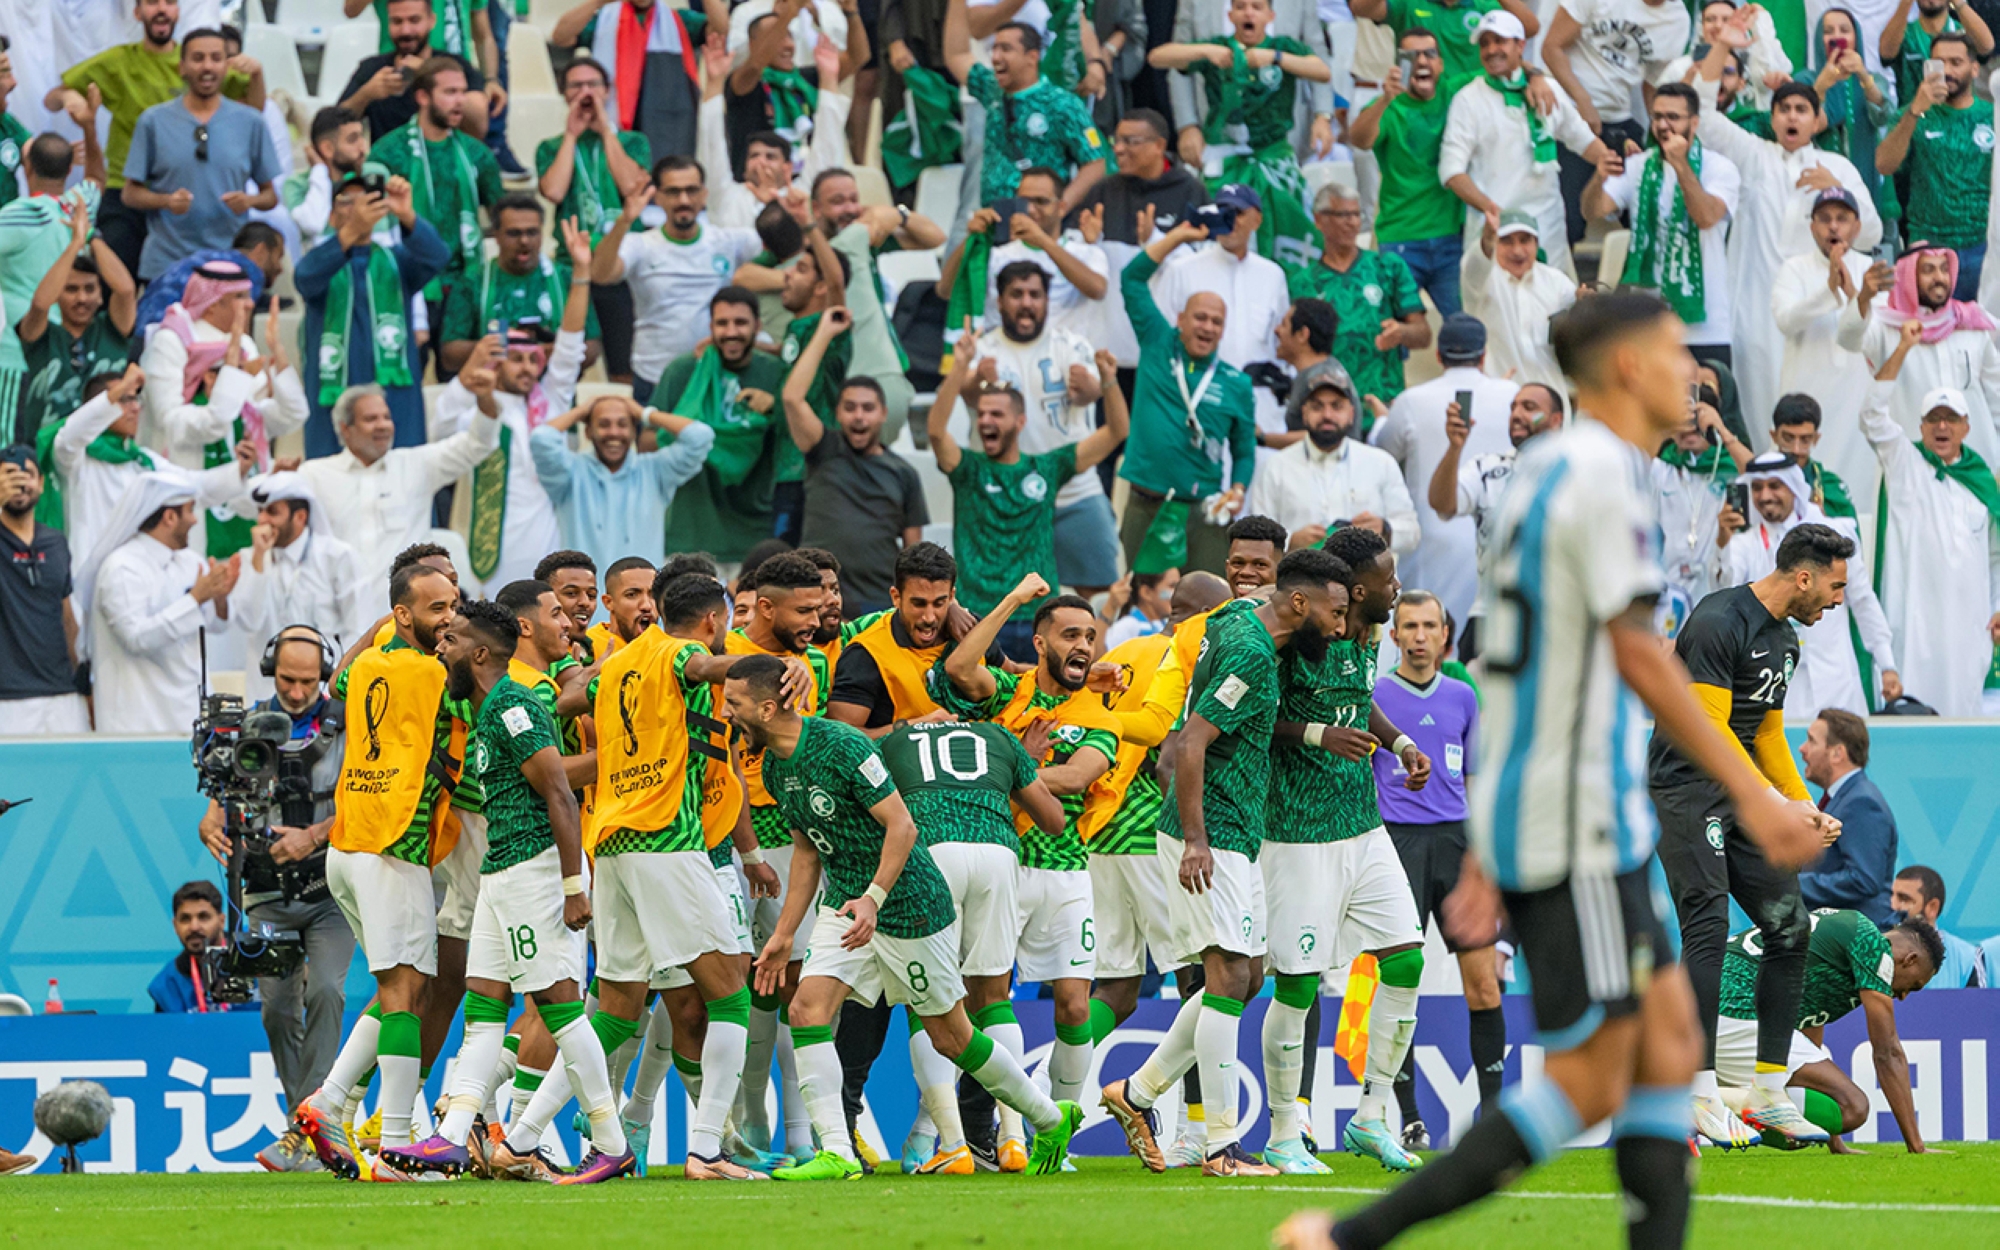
[1264,638,1382,844]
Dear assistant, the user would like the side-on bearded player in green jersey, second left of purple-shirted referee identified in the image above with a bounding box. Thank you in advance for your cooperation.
[1104,552,1348,1176]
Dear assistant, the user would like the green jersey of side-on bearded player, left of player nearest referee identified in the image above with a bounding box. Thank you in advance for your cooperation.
[1160,612,1278,862]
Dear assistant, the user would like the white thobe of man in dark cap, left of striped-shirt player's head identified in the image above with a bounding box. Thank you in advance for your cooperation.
[1372,368,1520,620]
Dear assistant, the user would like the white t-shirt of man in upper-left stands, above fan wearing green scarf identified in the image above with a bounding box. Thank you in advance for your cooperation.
[618,226,764,380]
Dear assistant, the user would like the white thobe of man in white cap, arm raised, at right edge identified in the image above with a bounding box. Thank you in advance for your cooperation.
[1862,382,2000,716]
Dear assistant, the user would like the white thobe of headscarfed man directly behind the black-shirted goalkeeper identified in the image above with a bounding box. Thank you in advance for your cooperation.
[1720,514,1896,724]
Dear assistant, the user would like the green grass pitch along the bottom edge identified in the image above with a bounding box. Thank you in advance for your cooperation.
[0,1144,2000,1250]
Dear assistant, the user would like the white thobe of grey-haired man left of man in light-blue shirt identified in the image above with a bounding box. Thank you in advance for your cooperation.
[300,418,508,584]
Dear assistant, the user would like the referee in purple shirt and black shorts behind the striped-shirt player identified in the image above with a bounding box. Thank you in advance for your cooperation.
[1372,590,1506,1152]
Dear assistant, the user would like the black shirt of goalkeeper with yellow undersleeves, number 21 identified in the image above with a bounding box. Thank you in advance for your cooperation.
[1646,586,1798,786]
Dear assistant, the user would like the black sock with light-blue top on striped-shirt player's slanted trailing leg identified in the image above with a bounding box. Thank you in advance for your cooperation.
[1334,1080,1568,1250]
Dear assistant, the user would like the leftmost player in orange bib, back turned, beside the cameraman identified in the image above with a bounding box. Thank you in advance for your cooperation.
[294,562,464,1178]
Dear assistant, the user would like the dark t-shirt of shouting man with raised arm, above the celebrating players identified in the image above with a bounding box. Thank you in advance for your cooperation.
[800,426,930,606]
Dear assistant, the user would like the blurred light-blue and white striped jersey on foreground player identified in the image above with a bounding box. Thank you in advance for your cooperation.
[1468,418,1666,890]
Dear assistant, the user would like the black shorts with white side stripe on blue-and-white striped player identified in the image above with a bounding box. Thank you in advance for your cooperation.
[1504,866,1674,1050]
